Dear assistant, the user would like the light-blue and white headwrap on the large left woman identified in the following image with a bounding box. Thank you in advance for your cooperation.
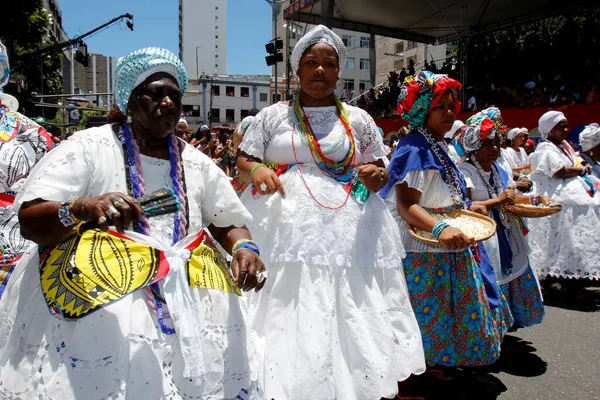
[115,47,188,114]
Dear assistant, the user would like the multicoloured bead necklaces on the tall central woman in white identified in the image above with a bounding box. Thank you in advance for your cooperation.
[292,97,358,210]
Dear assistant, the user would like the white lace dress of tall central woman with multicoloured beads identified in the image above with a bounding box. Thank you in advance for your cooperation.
[240,103,425,400]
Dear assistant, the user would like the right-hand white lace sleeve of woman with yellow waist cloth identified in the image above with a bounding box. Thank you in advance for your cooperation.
[198,154,252,227]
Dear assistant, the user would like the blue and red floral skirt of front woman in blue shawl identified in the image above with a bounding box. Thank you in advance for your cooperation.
[403,250,503,366]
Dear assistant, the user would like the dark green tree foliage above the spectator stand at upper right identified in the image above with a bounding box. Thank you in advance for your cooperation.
[457,8,600,87]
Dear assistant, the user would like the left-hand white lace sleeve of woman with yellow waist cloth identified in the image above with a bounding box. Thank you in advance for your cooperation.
[14,139,94,212]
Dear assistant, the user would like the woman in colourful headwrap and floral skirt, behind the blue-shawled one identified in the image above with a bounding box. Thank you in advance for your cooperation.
[458,118,549,327]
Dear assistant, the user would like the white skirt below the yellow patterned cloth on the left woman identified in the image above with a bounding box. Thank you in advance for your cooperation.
[0,247,262,400]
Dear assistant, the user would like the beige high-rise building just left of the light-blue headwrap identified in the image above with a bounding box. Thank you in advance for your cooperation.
[72,53,117,109]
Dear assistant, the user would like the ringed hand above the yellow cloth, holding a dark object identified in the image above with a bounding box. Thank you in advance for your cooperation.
[71,193,144,233]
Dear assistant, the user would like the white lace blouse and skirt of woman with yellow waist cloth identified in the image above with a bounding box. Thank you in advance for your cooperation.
[0,125,257,400]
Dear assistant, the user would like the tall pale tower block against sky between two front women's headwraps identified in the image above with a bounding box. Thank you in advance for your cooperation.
[179,0,227,80]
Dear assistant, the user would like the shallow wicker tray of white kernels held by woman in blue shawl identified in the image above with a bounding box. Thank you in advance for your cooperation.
[408,210,496,245]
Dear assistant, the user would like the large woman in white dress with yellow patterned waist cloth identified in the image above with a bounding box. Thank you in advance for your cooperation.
[0,48,264,400]
